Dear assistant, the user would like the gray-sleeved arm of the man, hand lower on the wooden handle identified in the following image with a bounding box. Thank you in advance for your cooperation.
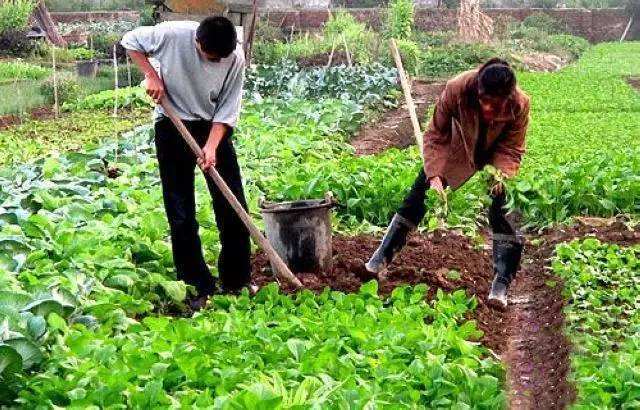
[199,57,244,171]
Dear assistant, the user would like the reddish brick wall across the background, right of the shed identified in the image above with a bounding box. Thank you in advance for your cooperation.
[266,8,640,43]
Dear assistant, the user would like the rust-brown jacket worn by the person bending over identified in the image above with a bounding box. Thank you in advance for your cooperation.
[424,70,529,189]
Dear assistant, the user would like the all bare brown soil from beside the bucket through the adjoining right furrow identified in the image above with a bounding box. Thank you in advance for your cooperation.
[252,220,640,409]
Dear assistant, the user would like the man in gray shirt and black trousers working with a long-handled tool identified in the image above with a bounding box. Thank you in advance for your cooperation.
[122,17,250,309]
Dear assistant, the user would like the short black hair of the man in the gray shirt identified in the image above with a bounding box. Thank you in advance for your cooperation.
[196,16,238,58]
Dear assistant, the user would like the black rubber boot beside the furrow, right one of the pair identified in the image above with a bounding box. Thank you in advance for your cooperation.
[489,234,524,307]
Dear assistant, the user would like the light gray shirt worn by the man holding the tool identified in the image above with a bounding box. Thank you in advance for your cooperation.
[121,21,245,127]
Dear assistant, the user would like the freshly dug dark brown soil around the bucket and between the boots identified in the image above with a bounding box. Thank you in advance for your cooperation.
[253,232,506,352]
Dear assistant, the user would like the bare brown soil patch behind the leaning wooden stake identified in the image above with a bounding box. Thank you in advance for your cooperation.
[351,81,444,155]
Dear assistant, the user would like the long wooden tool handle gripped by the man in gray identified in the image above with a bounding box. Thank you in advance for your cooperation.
[161,99,302,288]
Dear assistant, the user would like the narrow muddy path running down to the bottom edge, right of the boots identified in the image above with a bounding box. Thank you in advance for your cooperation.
[503,223,640,409]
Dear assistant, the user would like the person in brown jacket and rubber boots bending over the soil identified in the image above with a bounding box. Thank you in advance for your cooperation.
[366,59,529,306]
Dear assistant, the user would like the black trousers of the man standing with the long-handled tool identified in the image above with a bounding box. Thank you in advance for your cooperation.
[155,118,251,295]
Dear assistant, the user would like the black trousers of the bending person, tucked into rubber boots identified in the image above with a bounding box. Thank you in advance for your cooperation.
[398,169,516,235]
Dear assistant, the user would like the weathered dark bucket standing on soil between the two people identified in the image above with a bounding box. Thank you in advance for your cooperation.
[260,195,335,273]
